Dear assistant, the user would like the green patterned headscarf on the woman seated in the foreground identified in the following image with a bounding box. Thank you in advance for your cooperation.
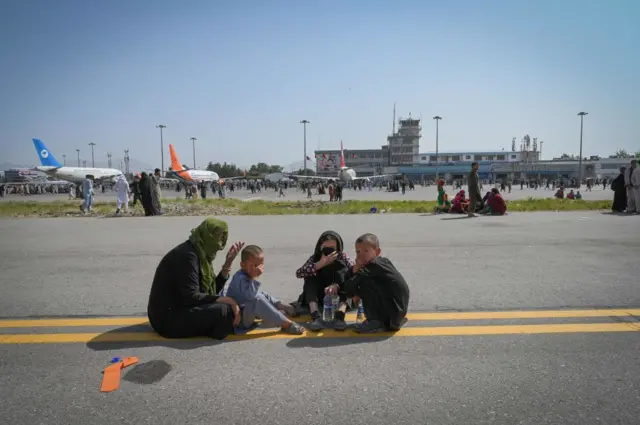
[189,218,229,295]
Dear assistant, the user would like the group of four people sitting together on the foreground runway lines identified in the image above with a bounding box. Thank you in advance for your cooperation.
[147,218,410,339]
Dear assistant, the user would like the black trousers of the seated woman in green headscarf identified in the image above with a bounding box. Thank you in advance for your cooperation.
[149,303,235,339]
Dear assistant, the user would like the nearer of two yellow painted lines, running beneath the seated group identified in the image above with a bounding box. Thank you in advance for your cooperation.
[0,323,640,344]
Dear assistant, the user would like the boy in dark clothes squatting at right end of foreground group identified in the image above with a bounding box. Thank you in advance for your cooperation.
[345,233,409,333]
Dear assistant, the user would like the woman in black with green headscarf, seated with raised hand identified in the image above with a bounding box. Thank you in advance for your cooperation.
[147,218,244,339]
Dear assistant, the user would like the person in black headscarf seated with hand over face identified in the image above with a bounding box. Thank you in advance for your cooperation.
[296,231,354,332]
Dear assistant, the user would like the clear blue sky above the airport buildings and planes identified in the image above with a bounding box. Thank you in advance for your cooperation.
[0,0,640,166]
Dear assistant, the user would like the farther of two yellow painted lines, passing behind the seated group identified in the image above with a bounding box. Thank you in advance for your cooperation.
[0,309,640,328]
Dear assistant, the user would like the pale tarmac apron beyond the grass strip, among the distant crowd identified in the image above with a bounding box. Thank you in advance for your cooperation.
[0,186,613,203]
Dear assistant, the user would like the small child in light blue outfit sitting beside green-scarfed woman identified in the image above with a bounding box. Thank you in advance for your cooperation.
[221,245,304,335]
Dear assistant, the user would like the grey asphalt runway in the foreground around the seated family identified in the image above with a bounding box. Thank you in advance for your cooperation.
[0,213,640,425]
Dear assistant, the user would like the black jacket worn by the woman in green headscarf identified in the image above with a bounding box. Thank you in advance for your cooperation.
[147,241,228,329]
